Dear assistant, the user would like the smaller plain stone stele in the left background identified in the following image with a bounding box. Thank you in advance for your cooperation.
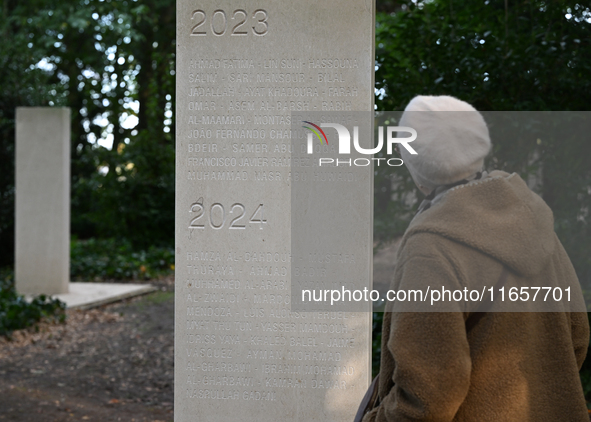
[15,107,70,294]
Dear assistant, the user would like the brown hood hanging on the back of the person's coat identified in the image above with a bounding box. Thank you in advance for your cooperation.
[401,171,555,276]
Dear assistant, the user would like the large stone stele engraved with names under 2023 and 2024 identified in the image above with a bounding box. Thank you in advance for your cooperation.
[174,0,374,422]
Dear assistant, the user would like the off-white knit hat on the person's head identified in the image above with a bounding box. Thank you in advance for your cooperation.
[399,95,491,189]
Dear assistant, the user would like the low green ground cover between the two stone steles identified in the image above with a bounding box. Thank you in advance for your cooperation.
[70,239,174,281]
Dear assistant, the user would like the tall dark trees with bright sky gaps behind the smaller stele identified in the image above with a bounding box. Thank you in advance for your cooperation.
[0,0,176,265]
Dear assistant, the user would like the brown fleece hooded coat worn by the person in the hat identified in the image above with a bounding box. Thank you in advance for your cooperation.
[363,171,589,422]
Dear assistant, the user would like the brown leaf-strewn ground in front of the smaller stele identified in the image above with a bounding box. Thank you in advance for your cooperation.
[0,278,174,422]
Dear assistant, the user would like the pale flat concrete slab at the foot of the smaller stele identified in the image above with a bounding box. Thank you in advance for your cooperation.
[52,282,157,309]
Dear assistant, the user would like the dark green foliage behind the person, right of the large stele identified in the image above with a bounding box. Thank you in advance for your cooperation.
[374,0,591,280]
